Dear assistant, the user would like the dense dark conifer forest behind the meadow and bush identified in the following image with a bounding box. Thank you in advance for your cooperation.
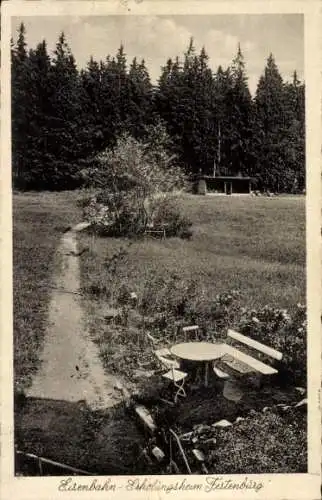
[11,24,305,193]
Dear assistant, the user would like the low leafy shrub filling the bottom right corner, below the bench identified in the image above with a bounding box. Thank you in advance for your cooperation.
[207,410,307,474]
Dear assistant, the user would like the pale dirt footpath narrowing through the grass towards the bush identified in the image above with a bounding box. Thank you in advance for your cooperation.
[26,223,121,410]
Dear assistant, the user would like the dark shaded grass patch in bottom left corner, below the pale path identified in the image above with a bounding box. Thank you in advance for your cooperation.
[15,397,147,476]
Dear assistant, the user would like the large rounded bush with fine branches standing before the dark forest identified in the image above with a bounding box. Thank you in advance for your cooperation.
[83,125,191,237]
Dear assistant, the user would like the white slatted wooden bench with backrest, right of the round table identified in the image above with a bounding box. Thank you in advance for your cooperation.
[213,330,283,384]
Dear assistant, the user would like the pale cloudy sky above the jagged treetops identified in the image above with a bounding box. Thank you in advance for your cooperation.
[12,14,304,93]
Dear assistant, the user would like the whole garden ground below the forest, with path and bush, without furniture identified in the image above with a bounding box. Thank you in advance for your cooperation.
[14,129,307,474]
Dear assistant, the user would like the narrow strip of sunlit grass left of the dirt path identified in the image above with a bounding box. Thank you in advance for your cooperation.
[13,193,80,390]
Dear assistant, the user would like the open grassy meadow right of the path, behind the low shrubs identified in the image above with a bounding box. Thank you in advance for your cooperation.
[82,195,305,309]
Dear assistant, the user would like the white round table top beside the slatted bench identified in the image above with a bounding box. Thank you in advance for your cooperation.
[170,342,224,361]
